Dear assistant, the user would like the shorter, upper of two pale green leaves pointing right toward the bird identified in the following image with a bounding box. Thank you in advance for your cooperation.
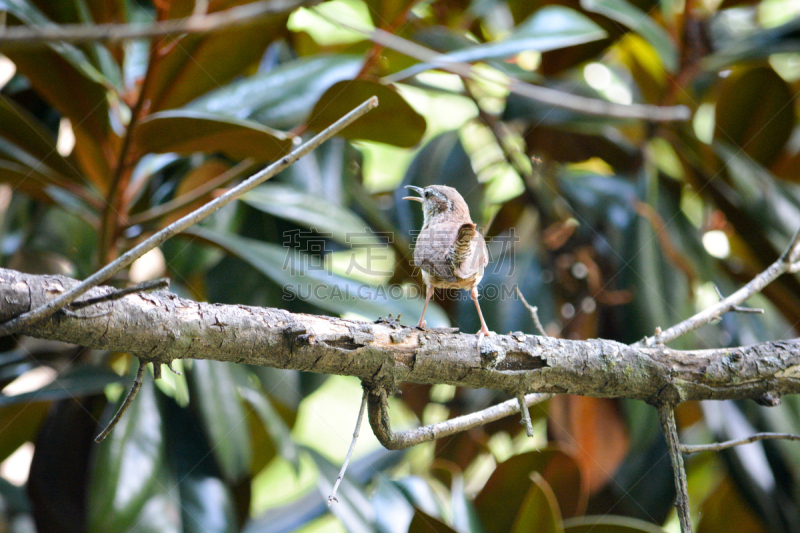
[241,183,379,245]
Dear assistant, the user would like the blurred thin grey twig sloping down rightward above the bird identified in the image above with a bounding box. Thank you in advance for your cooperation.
[314,10,691,122]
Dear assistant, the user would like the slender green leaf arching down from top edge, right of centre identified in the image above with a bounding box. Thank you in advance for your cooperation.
[581,0,678,72]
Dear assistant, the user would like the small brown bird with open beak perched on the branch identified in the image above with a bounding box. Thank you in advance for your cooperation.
[403,185,491,354]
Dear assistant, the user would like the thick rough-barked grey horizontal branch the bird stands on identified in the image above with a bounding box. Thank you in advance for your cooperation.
[0,269,800,405]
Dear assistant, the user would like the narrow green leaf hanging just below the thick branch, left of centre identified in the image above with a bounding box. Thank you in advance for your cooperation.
[189,360,252,482]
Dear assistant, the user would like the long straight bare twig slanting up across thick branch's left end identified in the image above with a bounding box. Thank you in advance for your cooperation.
[0,96,378,336]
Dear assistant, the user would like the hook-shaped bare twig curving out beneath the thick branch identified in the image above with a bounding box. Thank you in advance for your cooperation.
[368,388,553,450]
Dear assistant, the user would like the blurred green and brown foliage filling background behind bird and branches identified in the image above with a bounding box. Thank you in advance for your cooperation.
[0,0,800,533]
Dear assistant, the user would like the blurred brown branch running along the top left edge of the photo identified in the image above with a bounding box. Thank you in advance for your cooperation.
[0,0,318,49]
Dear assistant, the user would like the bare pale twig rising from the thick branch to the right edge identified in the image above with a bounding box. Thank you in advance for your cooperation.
[636,225,800,346]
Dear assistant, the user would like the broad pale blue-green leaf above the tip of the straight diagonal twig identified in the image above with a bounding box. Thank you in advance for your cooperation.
[188,55,363,130]
